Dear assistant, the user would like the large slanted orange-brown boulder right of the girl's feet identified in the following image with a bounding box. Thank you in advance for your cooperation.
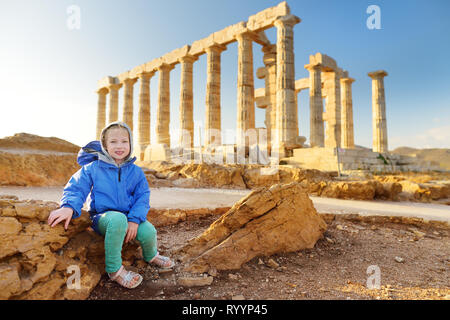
[178,182,326,273]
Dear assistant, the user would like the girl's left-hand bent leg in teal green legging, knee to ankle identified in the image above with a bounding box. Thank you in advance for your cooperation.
[98,211,128,273]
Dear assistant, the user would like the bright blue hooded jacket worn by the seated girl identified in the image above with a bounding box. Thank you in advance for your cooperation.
[60,122,150,233]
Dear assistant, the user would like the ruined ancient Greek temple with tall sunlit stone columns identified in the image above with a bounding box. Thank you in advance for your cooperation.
[97,2,436,170]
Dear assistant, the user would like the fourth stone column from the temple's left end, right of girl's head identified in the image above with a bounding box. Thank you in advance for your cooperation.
[135,72,154,161]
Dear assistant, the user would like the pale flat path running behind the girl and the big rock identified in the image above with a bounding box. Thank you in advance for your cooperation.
[0,187,450,223]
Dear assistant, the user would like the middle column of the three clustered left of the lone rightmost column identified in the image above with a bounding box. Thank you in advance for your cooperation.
[322,71,341,148]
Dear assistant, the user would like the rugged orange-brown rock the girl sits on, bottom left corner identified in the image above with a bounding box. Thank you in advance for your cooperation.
[0,199,137,300]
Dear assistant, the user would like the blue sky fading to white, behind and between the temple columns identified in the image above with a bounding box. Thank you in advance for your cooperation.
[0,0,450,149]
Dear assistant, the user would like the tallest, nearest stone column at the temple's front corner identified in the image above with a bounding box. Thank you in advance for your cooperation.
[272,15,301,157]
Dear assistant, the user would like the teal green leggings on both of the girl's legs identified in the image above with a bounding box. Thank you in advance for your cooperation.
[98,211,158,273]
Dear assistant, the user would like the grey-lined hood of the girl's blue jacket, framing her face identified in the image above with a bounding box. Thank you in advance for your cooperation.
[77,121,136,167]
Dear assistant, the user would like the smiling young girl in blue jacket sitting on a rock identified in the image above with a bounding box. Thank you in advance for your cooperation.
[48,122,174,288]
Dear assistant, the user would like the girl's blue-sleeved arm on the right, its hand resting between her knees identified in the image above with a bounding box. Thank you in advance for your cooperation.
[128,168,150,224]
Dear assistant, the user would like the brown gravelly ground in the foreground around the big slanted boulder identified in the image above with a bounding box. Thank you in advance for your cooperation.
[89,216,450,300]
